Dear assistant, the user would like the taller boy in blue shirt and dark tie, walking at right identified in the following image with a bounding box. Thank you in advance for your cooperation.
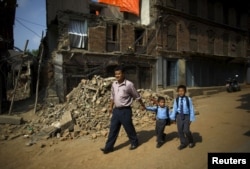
[170,85,195,150]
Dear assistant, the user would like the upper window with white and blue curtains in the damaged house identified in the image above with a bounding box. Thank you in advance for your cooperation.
[68,20,88,48]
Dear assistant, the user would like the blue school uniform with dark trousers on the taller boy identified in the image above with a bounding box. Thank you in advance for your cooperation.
[170,97,195,146]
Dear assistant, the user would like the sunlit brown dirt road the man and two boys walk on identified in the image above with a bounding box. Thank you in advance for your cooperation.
[0,88,250,169]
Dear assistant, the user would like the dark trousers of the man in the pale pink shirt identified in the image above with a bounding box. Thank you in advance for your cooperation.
[105,107,138,150]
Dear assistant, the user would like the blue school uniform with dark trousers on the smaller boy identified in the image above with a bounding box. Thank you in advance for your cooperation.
[146,106,169,143]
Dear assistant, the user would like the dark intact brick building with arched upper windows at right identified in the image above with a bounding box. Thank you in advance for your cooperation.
[155,0,249,88]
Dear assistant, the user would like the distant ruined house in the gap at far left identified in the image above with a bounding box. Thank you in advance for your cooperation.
[6,50,37,101]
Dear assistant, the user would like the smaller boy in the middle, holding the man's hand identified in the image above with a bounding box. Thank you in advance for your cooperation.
[146,97,169,148]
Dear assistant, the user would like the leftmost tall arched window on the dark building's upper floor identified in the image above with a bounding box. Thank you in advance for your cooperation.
[167,22,177,51]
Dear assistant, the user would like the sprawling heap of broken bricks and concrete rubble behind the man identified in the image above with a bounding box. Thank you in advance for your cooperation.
[0,75,172,146]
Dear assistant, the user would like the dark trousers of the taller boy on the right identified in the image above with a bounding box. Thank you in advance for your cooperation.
[176,114,193,145]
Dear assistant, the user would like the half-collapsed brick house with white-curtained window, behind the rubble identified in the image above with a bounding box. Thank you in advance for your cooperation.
[47,0,156,101]
